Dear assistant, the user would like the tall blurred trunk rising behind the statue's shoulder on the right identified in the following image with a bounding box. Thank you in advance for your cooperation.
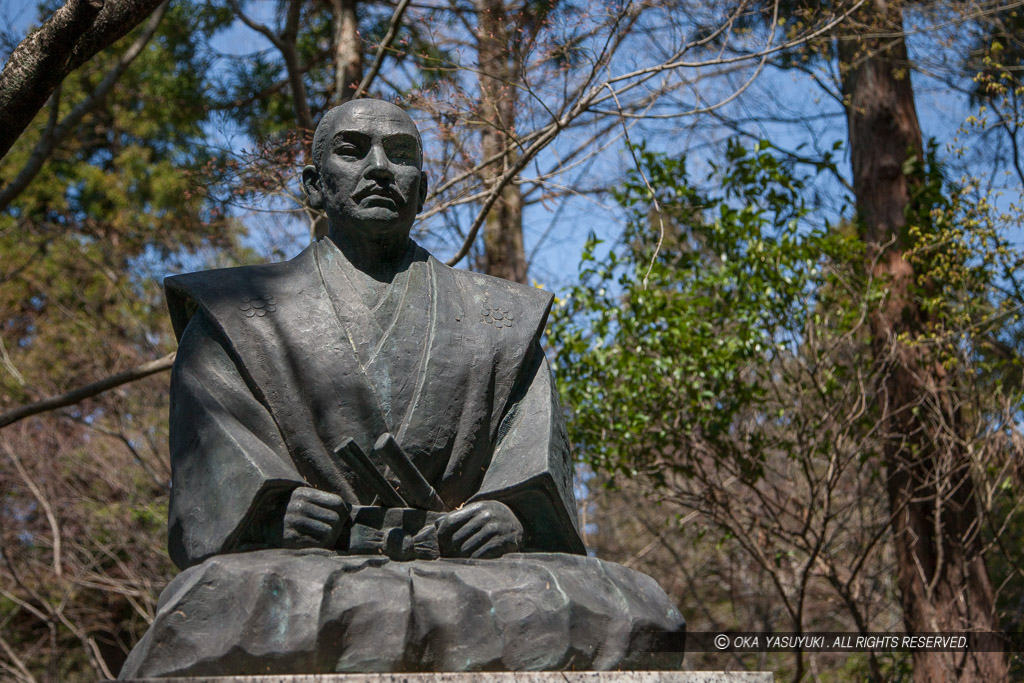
[476,0,526,283]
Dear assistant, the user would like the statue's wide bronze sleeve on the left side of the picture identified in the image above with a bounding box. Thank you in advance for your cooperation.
[168,311,303,569]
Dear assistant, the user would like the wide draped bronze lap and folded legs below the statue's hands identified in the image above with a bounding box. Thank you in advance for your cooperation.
[121,548,683,679]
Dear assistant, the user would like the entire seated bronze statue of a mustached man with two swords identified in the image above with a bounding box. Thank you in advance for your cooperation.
[121,99,683,678]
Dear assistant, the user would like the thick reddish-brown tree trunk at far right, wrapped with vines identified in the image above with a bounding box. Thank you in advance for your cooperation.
[839,0,1008,682]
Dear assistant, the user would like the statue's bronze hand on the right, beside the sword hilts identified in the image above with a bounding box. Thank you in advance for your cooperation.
[437,501,522,558]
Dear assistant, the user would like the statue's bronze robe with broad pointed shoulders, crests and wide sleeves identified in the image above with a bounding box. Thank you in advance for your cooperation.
[166,240,584,568]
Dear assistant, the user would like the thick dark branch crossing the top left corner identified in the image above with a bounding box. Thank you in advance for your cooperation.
[0,0,163,158]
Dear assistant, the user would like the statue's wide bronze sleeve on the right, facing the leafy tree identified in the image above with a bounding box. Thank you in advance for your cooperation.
[471,341,586,554]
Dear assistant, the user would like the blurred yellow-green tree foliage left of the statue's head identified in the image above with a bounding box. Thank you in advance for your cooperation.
[0,0,238,404]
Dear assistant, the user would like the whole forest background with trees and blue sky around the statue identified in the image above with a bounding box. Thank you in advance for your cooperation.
[0,0,1024,681]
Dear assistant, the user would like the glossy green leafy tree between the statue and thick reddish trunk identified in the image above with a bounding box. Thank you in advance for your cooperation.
[552,143,905,681]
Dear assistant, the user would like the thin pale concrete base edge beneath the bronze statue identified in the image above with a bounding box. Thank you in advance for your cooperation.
[121,671,775,683]
